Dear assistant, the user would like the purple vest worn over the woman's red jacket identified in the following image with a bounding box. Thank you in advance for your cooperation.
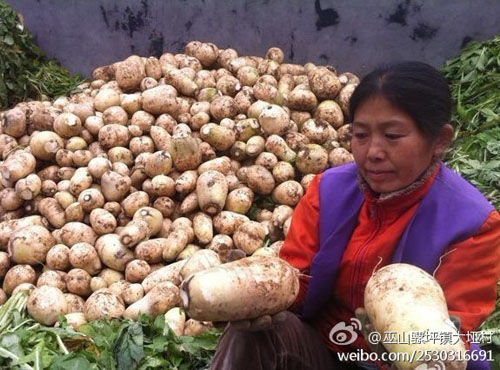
[302,163,494,370]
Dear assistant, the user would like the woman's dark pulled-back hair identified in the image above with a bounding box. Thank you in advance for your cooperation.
[349,62,452,140]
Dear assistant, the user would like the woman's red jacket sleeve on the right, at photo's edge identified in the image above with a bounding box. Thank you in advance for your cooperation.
[435,211,500,334]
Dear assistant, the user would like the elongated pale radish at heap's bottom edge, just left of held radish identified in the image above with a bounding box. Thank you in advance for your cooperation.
[123,282,179,320]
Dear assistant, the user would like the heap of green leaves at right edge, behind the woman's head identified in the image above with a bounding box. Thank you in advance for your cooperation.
[442,36,500,209]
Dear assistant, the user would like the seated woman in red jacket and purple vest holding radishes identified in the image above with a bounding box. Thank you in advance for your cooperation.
[212,62,500,369]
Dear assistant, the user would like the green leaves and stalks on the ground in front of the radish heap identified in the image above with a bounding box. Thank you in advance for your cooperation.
[0,291,220,370]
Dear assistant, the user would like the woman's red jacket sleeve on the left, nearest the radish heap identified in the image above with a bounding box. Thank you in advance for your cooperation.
[280,174,322,312]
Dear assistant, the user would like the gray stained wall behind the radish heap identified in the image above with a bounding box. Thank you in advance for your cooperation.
[7,0,500,75]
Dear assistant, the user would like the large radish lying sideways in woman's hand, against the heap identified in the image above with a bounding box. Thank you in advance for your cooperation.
[181,256,299,321]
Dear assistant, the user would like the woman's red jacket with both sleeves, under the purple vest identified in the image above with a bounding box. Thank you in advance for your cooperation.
[280,164,500,358]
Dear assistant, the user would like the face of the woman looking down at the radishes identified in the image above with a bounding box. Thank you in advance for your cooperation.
[352,96,451,193]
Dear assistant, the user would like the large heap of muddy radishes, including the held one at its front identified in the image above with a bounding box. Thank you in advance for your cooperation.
[0,41,359,335]
